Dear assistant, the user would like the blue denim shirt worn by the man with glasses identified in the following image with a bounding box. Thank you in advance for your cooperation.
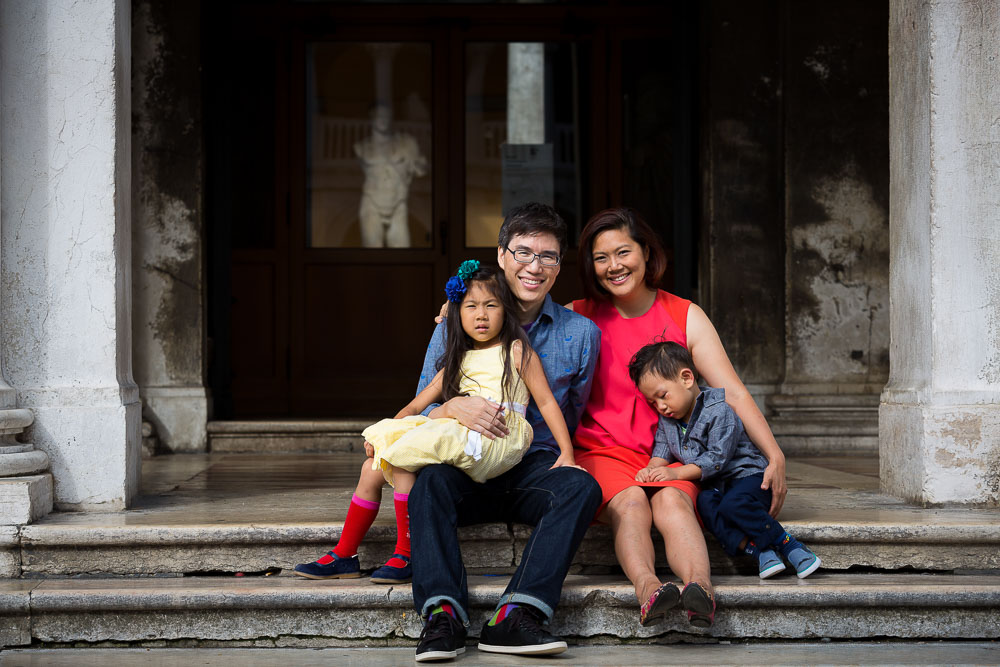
[417,295,601,454]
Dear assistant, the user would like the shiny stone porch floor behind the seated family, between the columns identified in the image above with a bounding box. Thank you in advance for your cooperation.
[31,453,1000,528]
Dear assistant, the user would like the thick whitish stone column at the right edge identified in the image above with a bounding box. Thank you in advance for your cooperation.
[879,0,1000,505]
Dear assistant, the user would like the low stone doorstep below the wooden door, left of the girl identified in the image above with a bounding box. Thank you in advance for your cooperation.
[207,418,377,453]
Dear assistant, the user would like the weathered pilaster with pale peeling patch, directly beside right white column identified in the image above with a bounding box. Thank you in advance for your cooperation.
[784,1,889,393]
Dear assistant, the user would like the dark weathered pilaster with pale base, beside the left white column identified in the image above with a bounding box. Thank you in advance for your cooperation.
[132,0,207,451]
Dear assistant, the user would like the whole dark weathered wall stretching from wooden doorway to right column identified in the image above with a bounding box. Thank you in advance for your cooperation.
[701,0,889,408]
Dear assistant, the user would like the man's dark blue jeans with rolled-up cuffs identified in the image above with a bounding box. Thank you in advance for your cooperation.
[409,451,601,624]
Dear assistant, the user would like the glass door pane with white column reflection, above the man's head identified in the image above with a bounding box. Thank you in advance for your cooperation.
[465,42,590,247]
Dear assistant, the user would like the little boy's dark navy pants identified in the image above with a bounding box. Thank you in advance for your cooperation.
[698,474,785,556]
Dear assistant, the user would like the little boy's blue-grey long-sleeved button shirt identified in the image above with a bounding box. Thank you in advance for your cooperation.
[653,387,767,480]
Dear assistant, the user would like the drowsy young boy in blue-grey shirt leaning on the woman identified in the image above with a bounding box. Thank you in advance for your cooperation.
[628,342,820,579]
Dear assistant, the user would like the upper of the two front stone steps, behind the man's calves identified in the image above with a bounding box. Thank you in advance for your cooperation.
[15,515,1000,578]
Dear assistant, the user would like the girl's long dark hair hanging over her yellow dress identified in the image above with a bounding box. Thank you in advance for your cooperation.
[437,266,532,403]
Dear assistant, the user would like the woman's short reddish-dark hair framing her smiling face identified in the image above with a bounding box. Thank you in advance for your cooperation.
[580,208,667,301]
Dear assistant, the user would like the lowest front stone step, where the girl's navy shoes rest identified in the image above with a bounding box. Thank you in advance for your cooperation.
[0,572,1000,646]
